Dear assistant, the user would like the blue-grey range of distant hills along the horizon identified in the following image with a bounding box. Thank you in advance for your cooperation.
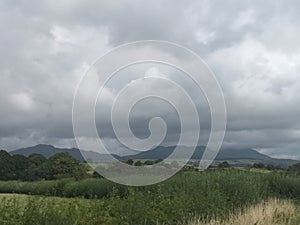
[10,145,299,168]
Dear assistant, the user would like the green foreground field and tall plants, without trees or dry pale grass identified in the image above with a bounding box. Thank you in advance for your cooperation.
[0,169,300,225]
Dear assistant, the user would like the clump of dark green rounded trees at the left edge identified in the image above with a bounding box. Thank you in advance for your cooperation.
[0,150,87,181]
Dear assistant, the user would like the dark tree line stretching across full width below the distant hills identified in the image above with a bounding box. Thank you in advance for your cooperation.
[0,150,300,181]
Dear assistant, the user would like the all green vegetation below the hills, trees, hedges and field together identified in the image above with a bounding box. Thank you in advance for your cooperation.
[0,151,300,225]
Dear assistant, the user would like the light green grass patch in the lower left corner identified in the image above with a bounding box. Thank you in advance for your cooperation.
[0,195,119,225]
